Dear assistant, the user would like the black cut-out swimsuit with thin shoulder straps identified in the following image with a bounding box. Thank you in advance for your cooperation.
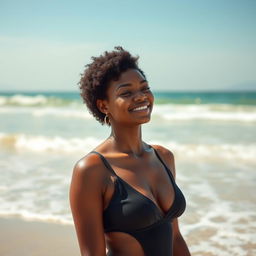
[91,149,186,256]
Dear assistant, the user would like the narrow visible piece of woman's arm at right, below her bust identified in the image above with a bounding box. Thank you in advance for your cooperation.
[172,218,191,256]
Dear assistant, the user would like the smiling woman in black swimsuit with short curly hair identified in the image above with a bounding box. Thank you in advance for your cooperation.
[70,47,190,256]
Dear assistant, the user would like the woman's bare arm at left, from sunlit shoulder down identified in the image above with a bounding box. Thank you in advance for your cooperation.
[69,155,106,256]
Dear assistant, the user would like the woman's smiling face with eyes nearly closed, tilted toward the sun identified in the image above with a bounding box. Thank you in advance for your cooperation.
[106,69,154,126]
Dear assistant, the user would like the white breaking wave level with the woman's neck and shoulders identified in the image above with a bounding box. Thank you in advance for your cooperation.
[0,134,256,162]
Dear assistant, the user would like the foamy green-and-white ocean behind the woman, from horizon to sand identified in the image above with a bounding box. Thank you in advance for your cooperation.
[0,91,256,256]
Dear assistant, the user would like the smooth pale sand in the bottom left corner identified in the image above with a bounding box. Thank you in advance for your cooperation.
[0,218,80,256]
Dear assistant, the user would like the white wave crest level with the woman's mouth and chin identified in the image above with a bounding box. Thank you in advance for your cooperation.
[0,104,256,122]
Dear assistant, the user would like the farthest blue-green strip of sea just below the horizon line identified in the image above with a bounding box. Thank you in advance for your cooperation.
[0,90,256,107]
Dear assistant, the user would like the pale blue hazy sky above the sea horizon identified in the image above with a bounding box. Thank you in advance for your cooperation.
[0,0,256,91]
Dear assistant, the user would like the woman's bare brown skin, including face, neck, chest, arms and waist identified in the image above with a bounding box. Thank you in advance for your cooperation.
[70,69,190,256]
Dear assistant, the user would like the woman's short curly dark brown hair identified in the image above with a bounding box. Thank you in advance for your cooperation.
[78,46,146,124]
